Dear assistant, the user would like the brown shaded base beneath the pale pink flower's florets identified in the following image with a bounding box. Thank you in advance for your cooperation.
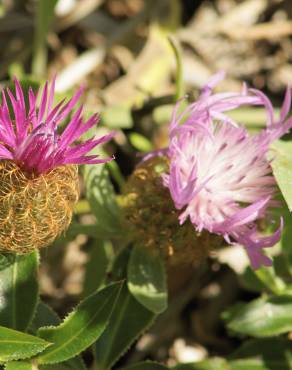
[120,156,223,268]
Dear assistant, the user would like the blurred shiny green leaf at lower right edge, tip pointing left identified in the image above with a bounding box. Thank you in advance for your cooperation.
[223,296,292,337]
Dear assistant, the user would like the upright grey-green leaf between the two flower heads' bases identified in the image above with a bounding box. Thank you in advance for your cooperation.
[84,165,121,233]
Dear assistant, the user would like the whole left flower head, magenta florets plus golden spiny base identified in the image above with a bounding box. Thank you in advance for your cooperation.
[0,79,112,253]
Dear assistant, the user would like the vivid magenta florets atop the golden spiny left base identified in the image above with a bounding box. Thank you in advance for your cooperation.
[0,79,113,174]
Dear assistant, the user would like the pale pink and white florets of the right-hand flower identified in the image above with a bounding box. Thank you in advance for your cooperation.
[163,72,292,269]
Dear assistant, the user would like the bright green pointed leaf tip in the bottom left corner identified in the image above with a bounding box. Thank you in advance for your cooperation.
[0,326,50,362]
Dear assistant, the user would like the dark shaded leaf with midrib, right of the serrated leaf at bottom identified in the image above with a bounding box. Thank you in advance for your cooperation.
[95,285,155,369]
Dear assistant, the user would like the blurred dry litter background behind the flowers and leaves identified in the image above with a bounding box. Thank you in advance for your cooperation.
[0,0,292,365]
